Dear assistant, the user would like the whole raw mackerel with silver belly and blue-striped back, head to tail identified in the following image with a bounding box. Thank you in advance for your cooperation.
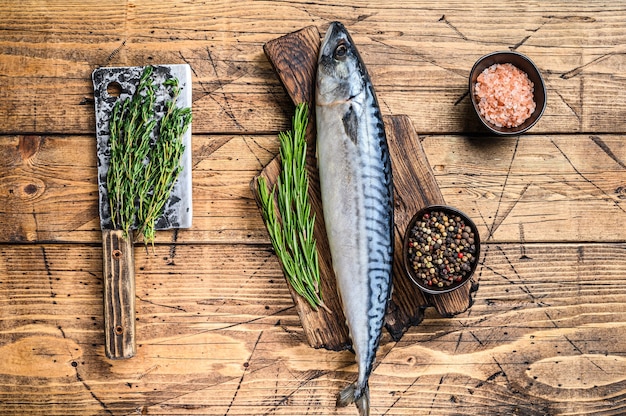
[315,22,393,415]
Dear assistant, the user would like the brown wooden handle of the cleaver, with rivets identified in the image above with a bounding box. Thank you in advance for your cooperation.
[102,230,136,359]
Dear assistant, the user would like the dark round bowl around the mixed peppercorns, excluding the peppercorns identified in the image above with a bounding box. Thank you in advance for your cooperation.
[402,205,480,295]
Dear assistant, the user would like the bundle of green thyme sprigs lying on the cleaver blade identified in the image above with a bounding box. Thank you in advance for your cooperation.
[107,66,192,243]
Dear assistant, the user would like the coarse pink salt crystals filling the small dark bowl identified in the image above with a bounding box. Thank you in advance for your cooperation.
[474,63,536,128]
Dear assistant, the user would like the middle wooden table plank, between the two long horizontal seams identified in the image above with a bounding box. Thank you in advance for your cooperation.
[0,133,626,244]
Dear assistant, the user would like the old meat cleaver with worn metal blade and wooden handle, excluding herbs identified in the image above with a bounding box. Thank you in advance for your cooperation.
[91,64,192,359]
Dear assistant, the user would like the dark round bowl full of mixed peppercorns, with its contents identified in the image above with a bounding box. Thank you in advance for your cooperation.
[403,205,480,294]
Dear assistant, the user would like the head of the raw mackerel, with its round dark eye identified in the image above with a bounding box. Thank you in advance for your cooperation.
[316,22,369,105]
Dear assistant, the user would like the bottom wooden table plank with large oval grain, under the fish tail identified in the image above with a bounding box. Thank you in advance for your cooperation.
[0,243,626,415]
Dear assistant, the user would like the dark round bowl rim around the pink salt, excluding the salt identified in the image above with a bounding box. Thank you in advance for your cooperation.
[469,51,546,135]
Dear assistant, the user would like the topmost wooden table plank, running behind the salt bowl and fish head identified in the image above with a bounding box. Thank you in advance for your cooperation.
[0,0,626,134]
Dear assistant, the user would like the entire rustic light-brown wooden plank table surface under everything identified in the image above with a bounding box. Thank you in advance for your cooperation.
[0,0,626,415]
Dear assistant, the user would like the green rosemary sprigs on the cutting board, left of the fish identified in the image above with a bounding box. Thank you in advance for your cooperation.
[258,103,326,310]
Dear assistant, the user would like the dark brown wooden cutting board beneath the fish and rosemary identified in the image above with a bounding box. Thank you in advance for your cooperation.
[251,26,477,350]
